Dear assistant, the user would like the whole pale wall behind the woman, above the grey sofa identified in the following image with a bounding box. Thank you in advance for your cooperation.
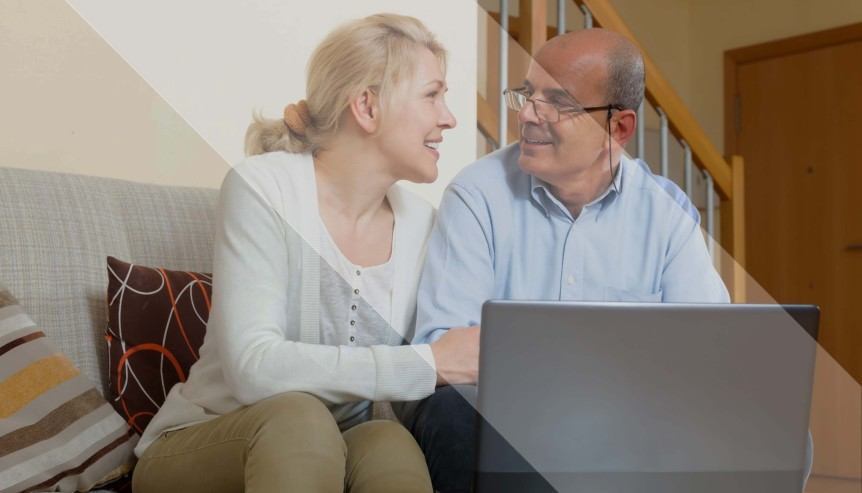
[0,0,476,204]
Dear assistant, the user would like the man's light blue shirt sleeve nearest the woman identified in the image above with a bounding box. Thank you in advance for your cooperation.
[413,183,494,344]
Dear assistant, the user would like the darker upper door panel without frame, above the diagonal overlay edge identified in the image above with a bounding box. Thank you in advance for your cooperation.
[731,24,862,381]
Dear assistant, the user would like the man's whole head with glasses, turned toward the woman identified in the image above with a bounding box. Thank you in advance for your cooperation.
[518,29,644,186]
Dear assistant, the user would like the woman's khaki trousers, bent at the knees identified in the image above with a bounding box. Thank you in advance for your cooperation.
[132,392,432,493]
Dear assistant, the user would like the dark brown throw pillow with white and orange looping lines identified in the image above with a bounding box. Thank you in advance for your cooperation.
[105,257,212,433]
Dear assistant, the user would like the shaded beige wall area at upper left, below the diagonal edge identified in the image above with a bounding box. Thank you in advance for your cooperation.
[0,0,227,187]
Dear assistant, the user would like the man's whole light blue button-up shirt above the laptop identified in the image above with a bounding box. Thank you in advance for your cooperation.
[414,144,729,343]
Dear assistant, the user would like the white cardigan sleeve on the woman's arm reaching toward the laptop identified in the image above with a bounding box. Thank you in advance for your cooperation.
[207,164,436,404]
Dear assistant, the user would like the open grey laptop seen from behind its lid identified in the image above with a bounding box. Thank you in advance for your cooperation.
[475,301,819,493]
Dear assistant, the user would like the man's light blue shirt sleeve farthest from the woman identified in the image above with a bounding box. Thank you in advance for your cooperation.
[661,202,730,303]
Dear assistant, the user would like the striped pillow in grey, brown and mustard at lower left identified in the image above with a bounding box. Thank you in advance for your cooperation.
[0,286,135,493]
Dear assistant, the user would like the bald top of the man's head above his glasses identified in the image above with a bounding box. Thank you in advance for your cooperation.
[535,29,644,110]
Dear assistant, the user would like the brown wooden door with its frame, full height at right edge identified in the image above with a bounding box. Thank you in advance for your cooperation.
[725,25,862,491]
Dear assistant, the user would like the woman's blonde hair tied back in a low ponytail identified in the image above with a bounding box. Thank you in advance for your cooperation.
[245,14,446,156]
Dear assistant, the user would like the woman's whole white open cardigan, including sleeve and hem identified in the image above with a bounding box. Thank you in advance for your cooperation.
[141,152,437,457]
